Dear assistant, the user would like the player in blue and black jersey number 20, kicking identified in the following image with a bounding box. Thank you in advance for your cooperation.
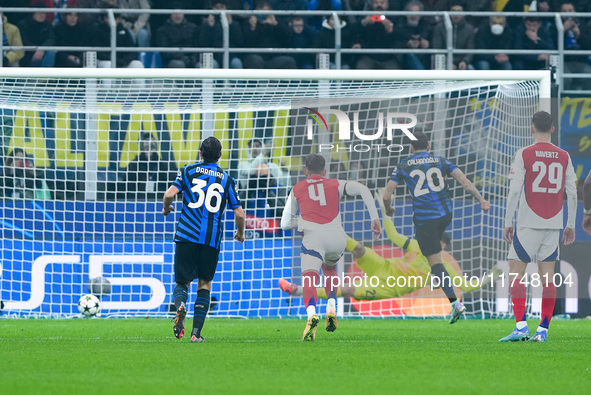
[382,132,490,324]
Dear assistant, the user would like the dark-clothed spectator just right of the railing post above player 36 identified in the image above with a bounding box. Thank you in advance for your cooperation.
[243,1,296,69]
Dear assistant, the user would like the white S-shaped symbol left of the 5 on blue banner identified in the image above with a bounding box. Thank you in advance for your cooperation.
[4,255,80,310]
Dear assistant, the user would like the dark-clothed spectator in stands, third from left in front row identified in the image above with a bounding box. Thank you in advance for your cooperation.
[55,12,91,67]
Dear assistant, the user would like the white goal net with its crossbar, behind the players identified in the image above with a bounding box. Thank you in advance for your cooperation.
[0,69,550,317]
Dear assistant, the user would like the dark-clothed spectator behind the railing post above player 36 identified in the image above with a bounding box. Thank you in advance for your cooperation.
[199,0,242,69]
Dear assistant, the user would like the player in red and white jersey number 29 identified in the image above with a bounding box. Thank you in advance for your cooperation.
[500,111,577,341]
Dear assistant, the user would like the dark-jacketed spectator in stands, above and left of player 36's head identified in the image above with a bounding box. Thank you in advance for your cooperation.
[156,6,199,68]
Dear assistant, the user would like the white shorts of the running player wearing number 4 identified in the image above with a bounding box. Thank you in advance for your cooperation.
[301,228,347,273]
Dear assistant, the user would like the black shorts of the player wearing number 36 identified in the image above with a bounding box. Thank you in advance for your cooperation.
[174,243,220,284]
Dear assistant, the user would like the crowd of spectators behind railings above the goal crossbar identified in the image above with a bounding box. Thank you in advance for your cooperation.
[3,0,591,74]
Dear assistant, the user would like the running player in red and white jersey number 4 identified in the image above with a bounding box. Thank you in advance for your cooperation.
[281,154,382,341]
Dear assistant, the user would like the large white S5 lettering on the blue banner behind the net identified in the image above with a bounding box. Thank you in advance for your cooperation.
[4,255,166,310]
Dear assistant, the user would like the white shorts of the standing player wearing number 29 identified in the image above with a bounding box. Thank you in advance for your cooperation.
[508,227,560,263]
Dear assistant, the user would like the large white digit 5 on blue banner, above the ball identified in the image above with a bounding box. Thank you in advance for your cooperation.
[88,255,166,310]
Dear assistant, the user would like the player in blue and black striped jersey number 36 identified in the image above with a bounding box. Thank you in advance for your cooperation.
[162,137,245,343]
